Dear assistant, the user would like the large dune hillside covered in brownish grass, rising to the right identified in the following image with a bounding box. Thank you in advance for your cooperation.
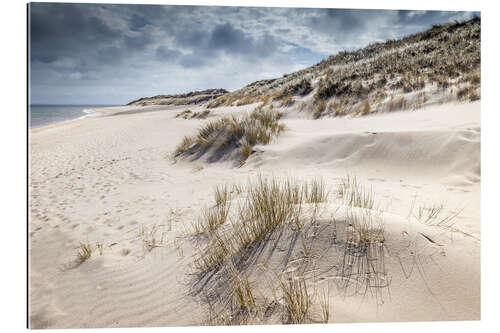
[202,18,481,118]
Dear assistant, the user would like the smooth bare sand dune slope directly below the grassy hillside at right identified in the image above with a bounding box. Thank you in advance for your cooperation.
[254,103,481,181]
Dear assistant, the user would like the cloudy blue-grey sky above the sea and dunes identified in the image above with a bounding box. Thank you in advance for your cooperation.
[29,3,479,105]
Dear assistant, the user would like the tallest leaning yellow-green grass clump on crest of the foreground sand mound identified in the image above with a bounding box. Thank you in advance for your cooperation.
[195,177,327,273]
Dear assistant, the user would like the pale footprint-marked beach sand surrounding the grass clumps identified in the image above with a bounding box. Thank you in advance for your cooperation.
[29,101,481,328]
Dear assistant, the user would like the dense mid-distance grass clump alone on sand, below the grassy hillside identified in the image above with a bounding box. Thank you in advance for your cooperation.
[174,107,285,161]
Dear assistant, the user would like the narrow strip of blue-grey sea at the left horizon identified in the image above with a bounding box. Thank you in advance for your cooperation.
[29,104,118,128]
